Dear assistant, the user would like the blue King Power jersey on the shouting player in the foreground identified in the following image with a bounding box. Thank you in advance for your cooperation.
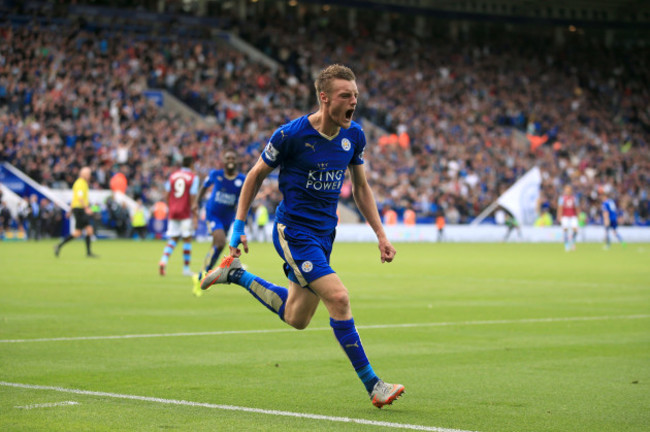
[262,115,366,235]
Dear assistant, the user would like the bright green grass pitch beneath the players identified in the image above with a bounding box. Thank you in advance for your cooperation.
[0,241,650,432]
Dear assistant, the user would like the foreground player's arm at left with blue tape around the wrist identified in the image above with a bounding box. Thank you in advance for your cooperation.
[230,158,273,257]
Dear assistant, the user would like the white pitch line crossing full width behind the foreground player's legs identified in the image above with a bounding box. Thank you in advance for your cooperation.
[0,315,650,343]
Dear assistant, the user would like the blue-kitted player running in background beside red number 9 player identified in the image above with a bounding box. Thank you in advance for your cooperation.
[193,150,246,296]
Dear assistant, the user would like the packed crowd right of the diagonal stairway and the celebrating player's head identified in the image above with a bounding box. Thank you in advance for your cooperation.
[235,7,650,224]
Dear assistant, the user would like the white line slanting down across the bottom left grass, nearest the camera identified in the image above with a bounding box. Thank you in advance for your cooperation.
[0,381,472,432]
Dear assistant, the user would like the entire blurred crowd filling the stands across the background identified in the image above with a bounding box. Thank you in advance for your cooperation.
[0,1,650,235]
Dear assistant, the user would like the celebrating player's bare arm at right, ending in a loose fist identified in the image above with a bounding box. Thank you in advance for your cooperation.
[350,165,397,262]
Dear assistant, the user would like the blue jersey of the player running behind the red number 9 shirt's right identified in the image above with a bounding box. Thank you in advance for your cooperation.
[203,169,246,220]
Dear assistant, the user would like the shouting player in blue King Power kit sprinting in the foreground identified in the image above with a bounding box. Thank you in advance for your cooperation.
[195,65,404,408]
